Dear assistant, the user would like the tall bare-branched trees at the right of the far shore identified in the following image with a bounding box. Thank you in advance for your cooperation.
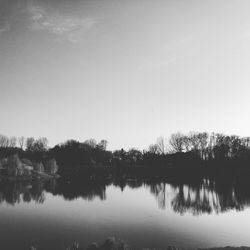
[149,132,250,160]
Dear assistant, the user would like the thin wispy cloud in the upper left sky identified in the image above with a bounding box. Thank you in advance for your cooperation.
[27,1,96,43]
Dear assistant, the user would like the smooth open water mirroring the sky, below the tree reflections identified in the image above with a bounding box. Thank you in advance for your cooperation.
[0,185,250,250]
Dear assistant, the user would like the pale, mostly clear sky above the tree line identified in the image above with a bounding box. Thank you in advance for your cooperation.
[0,0,250,150]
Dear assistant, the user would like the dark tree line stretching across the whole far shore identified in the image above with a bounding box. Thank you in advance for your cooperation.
[0,132,250,169]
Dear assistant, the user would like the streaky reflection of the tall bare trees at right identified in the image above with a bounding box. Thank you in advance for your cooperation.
[148,179,250,215]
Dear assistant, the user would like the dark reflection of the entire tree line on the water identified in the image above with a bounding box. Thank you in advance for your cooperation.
[0,173,250,215]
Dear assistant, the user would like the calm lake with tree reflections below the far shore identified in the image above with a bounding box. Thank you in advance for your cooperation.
[0,174,250,250]
